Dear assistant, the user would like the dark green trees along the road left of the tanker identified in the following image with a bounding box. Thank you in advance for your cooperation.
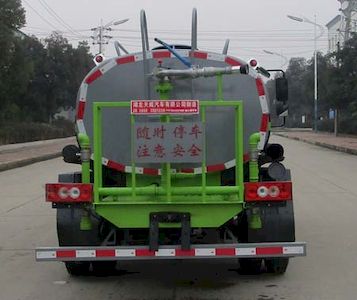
[0,0,93,125]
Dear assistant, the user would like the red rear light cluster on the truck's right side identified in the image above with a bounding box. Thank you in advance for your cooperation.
[244,181,292,202]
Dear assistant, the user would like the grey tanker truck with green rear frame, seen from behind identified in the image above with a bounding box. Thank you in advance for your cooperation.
[36,8,306,275]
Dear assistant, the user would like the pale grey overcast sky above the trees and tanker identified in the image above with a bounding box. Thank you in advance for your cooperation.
[22,0,340,68]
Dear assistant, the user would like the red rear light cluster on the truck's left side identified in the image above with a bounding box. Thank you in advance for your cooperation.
[46,183,93,203]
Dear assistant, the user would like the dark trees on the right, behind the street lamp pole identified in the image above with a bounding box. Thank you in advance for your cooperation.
[278,34,357,134]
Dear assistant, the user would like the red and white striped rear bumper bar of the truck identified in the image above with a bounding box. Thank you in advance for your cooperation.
[36,242,306,261]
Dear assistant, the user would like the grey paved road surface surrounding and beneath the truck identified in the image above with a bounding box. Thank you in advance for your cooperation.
[0,138,357,300]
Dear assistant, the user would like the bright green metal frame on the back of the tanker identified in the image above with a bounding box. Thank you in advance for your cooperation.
[89,101,244,228]
